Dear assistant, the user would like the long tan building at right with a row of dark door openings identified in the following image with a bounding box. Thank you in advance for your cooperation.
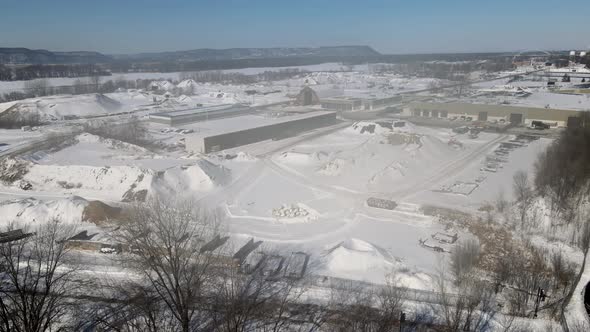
[403,103,579,127]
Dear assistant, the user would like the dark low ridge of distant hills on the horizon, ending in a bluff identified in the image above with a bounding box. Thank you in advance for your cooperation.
[0,46,381,65]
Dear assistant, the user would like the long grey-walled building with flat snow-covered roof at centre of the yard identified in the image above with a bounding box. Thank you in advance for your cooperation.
[183,111,337,153]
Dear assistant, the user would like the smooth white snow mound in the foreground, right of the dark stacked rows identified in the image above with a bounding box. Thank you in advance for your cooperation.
[322,238,395,280]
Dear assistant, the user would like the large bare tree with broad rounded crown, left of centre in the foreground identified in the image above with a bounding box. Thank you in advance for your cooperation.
[119,198,223,332]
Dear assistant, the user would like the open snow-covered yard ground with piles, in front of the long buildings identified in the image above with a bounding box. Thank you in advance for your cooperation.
[0,110,549,289]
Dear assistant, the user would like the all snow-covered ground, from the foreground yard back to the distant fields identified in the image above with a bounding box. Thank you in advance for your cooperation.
[0,64,587,296]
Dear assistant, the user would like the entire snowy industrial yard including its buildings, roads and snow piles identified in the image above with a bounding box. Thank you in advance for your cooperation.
[0,55,588,330]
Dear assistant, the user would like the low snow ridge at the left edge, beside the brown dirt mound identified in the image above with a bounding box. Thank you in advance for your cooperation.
[0,196,88,226]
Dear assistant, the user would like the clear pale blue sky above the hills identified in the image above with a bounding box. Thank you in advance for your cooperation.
[0,0,590,53]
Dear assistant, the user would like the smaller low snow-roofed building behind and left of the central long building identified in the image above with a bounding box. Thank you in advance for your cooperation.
[150,104,254,126]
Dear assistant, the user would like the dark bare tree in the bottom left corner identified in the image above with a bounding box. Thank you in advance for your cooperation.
[0,220,75,332]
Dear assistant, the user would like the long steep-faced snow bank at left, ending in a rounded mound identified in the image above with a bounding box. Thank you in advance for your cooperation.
[3,158,231,201]
